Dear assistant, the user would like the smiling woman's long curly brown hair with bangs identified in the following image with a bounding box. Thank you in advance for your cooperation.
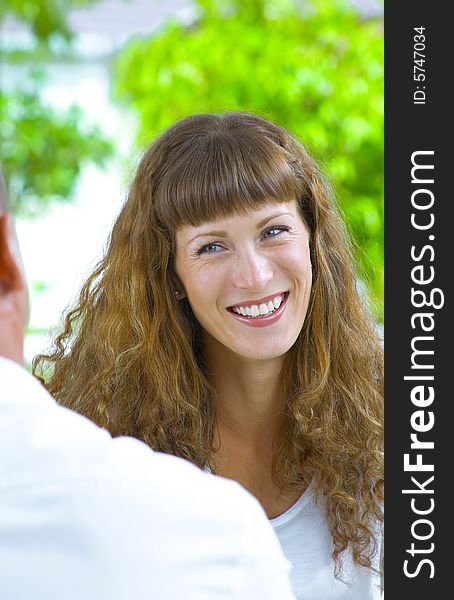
[33,112,383,572]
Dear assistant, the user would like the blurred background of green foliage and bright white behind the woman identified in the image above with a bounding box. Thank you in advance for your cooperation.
[0,0,383,366]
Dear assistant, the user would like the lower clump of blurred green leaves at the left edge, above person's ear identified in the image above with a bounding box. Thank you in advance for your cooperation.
[0,83,112,217]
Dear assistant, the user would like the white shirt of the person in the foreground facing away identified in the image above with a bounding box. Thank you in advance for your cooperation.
[0,358,294,600]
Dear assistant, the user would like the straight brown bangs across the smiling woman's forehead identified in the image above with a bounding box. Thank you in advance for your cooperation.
[155,125,302,231]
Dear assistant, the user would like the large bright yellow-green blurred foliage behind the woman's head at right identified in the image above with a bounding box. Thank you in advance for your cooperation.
[115,0,383,320]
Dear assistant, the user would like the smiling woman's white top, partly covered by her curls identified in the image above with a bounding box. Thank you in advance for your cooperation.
[271,486,381,600]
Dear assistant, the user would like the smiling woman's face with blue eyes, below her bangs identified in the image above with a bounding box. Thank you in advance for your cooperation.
[175,201,312,359]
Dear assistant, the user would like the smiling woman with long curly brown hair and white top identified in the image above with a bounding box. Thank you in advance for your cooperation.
[35,113,383,600]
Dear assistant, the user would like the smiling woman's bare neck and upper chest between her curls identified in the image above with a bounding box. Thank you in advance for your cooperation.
[204,340,303,518]
